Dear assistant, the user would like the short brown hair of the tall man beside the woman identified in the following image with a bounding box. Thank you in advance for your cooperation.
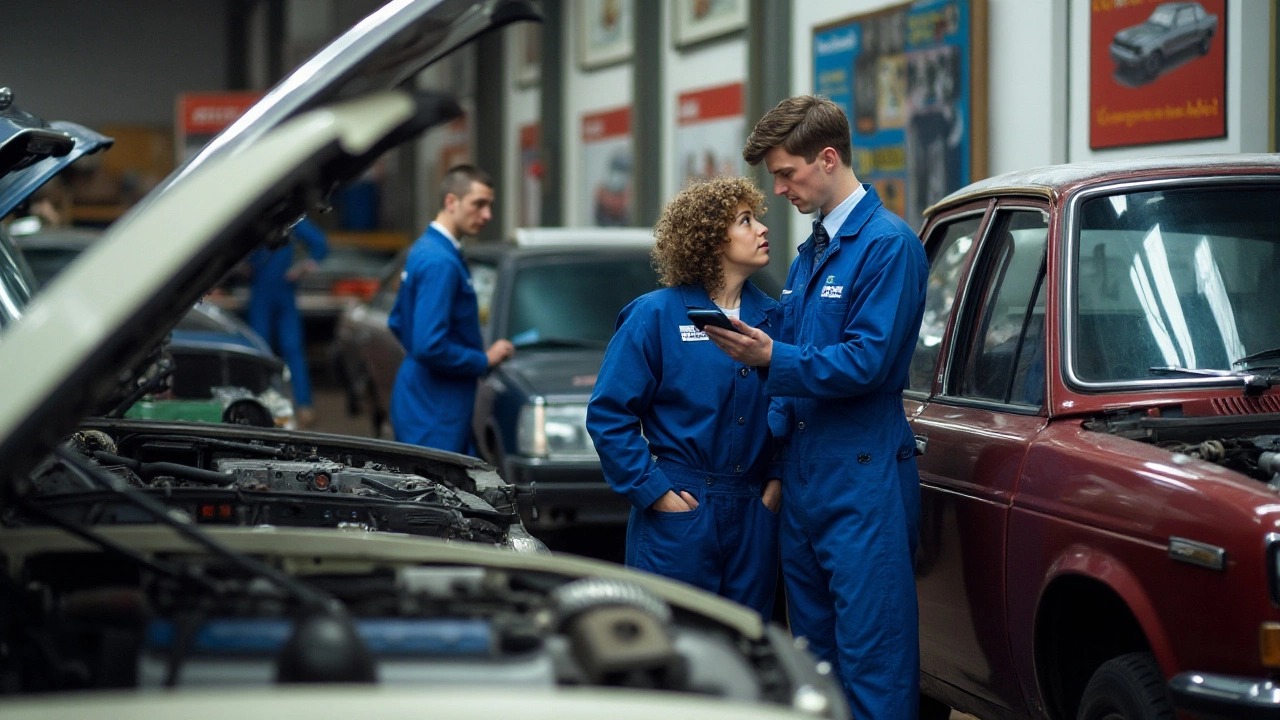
[742,95,854,168]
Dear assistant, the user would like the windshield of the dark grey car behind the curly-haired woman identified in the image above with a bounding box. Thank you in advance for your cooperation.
[507,254,658,347]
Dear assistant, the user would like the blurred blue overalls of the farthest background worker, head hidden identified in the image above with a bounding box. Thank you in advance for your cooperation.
[246,218,329,407]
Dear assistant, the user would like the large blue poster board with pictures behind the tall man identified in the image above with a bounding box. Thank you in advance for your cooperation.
[813,0,987,227]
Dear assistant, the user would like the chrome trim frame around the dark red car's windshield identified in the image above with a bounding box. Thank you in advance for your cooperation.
[1059,174,1280,393]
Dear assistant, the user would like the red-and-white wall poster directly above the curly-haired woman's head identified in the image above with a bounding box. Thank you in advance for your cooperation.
[673,82,746,188]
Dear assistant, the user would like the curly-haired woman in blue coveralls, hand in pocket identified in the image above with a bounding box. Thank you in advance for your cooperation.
[586,177,782,619]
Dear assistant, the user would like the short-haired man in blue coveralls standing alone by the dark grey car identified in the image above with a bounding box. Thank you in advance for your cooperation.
[387,165,515,455]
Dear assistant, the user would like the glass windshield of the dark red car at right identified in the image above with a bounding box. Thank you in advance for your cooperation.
[1073,186,1280,382]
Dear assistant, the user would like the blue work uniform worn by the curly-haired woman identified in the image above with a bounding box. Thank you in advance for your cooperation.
[586,283,778,619]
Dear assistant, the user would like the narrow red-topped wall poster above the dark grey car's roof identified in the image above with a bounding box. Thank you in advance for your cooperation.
[582,108,634,227]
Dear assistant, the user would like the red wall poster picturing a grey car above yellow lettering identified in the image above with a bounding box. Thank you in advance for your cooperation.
[1089,0,1226,150]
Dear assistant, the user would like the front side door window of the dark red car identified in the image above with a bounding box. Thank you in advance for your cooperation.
[952,210,1048,406]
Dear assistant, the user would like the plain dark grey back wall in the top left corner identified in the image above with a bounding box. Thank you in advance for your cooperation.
[0,0,228,127]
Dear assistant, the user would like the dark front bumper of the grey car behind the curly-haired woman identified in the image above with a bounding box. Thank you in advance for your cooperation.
[503,457,631,529]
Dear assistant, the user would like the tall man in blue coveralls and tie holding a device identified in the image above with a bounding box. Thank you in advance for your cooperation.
[707,95,928,719]
